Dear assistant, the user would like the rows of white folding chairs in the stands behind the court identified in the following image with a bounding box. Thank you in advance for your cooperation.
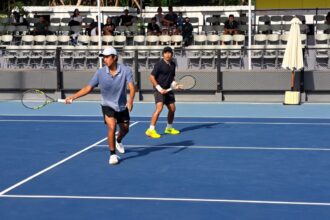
[0,10,330,69]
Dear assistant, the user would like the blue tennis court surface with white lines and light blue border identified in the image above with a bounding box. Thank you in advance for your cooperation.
[0,102,330,220]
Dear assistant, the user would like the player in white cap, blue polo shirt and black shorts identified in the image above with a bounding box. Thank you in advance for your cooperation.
[66,46,135,165]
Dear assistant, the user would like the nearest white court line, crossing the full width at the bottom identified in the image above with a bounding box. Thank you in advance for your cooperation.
[0,195,330,206]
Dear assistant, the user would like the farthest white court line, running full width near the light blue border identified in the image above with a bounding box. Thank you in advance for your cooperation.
[0,119,330,126]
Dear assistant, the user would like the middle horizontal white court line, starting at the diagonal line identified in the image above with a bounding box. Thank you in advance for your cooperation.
[97,144,330,151]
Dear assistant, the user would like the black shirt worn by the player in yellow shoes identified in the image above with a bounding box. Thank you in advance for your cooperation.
[151,59,176,89]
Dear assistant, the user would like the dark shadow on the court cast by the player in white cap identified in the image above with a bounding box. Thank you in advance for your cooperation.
[122,140,194,161]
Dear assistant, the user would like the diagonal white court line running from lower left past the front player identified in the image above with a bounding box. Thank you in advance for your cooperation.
[0,121,139,197]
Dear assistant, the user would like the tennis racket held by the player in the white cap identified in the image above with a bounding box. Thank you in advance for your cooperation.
[22,89,65,110]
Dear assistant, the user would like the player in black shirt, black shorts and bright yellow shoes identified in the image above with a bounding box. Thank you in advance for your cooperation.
[146,47,180,138]
